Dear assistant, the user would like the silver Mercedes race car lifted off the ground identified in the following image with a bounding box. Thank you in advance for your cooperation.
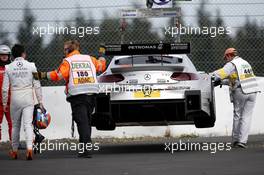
[92,43,215,130]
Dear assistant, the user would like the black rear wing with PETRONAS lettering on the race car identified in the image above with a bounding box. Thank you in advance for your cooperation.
[105,43,191,56]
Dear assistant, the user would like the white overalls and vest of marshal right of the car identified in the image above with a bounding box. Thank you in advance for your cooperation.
[214,56,259,143]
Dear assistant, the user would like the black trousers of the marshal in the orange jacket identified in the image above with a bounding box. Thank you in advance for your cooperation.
[67,94,95,144]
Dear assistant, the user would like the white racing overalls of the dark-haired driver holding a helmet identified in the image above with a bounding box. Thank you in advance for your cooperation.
[2,57,42,151]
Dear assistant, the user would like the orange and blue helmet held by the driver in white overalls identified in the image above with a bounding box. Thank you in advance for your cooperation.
[33,105,51,129]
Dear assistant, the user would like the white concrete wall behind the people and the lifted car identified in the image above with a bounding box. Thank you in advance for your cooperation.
[2,78,264,140]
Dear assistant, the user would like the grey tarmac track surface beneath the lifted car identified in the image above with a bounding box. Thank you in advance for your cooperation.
[0,136,264,175]
